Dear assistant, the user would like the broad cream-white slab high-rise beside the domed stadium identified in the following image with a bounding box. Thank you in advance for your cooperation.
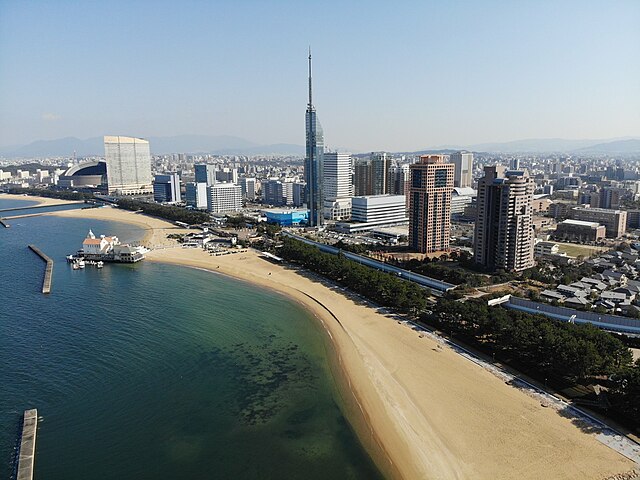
[104,135,153,195]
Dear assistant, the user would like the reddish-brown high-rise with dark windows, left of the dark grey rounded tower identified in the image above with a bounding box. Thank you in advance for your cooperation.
[409,155,455,253]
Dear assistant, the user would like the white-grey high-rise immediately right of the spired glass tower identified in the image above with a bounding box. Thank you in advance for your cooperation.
[323,152,353,220]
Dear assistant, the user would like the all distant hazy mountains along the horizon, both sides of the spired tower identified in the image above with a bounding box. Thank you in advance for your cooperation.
[0,135,640,158]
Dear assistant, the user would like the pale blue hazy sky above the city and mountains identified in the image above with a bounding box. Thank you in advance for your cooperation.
[0,0,640,151]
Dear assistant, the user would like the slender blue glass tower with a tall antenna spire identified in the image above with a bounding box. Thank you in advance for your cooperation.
[304,50,324,227]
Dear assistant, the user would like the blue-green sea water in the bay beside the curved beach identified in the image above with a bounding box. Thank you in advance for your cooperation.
[0,197,382,480]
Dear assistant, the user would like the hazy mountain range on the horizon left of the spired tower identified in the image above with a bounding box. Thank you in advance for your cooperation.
[0,135,304,158]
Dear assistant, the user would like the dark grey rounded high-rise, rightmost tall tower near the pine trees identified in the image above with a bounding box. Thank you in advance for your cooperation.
[474,165,535,272]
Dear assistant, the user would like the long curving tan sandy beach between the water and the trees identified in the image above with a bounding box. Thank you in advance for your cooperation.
[45,204,636,480]
